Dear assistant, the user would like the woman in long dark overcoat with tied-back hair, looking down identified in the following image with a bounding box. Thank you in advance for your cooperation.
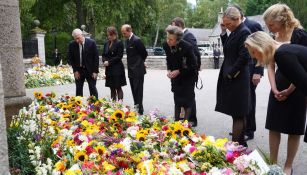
[215,7,251,146]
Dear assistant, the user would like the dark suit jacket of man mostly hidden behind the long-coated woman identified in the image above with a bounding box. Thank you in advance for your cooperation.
[244,18,263,75]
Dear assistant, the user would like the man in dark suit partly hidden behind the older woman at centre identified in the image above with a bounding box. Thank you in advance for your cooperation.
[172,17,201,127]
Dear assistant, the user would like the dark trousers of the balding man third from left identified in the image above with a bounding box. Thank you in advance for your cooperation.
[129,76,144,115]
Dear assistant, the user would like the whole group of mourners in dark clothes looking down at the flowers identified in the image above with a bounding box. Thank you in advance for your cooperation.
[69,3,307,175]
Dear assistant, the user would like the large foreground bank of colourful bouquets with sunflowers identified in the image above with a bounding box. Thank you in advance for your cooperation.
[10,92,261,175]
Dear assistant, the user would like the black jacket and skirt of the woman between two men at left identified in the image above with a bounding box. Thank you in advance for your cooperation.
[102,40,127,88]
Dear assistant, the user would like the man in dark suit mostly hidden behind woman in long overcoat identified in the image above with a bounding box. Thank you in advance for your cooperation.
[233,4,263,140]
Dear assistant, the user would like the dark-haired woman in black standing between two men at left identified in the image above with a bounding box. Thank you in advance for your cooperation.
[102,27,127,101]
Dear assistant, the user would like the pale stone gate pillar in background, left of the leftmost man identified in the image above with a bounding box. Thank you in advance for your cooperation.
[32,29,46,65]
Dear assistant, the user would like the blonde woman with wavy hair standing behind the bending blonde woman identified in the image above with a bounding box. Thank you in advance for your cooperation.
[263,3,307,174]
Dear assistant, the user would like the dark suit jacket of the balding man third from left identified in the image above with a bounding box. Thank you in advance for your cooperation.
[126,34,148,78]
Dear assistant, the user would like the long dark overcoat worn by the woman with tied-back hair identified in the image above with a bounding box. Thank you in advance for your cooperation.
[215,23,251,117]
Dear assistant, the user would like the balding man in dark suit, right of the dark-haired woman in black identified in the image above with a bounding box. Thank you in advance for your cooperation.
[121,24,148,115]
